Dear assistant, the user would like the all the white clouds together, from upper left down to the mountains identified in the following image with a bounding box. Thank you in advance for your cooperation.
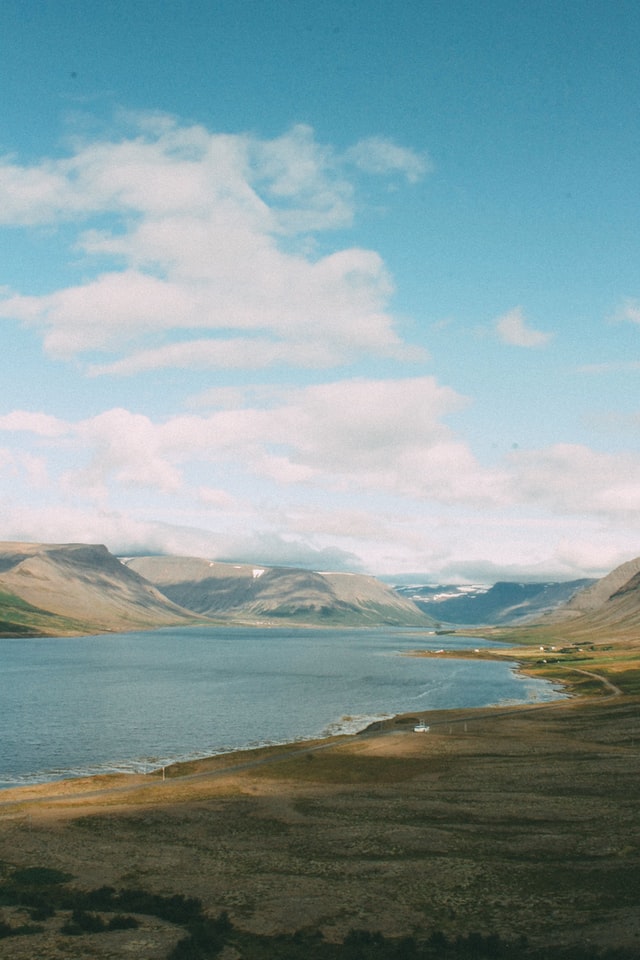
[0,114,640,578]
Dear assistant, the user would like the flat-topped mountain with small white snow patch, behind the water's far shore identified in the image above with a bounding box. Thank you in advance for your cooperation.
[126,557,433,627]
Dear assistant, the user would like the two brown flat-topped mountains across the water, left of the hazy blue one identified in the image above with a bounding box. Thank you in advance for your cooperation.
[0,543,433,636]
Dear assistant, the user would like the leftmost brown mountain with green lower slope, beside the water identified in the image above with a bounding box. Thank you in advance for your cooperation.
[0,542,197,636]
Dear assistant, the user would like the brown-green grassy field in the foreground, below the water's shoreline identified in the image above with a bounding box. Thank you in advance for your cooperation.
[0,641,640,960]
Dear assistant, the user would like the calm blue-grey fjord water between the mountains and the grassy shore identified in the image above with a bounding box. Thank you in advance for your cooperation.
[0,627,560,787]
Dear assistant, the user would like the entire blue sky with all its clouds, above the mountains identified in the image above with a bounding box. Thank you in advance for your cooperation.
[0,0,640,583]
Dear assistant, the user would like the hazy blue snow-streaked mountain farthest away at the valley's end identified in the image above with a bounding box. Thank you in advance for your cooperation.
[396,579,594,626]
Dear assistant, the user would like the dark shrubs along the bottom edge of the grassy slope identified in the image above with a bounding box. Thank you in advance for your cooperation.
[0,867,637,960]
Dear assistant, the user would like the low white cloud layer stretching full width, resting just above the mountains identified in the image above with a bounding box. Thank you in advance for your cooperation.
[0,404,640,579]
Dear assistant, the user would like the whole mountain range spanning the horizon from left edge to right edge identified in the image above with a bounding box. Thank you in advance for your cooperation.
[0,542,640,637]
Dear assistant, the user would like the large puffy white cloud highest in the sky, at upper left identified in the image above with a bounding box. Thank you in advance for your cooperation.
[0,117,430,375]
